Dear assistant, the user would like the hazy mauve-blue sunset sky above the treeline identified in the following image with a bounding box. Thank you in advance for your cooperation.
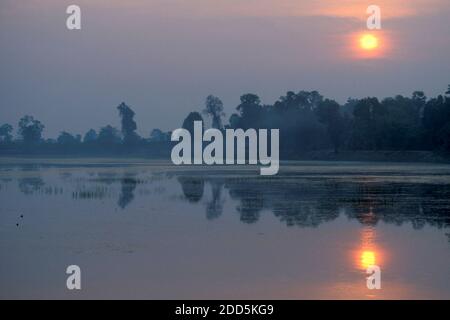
[0,0,450,137]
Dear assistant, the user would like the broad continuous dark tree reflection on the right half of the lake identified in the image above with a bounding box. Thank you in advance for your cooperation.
[178,176,450,228]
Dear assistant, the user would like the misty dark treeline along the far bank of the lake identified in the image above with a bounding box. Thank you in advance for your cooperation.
[0,85,450,159]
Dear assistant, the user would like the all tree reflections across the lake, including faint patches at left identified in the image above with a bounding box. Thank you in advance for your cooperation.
[9,168,450,232]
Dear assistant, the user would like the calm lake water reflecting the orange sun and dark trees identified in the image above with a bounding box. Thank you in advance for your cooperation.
[0,159,450,299]
